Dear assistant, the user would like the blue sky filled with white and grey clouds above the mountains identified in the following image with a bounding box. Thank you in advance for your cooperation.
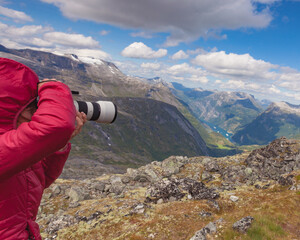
[0,0,300,105]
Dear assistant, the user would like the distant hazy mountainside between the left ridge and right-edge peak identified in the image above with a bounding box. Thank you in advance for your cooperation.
[173,83,263,133]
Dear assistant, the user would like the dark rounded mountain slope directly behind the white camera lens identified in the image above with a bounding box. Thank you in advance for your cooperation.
[61,98,208,179]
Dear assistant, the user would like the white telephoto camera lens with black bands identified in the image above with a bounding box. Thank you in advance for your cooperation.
[74,101,118,123]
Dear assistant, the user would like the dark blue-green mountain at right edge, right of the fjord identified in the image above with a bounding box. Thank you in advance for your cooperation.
[232,102,300,145]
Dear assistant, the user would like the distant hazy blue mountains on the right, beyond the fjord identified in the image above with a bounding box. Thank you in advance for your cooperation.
[172,83,300,145]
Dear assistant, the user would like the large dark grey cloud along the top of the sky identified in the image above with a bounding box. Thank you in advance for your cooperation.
[42,0,277,46]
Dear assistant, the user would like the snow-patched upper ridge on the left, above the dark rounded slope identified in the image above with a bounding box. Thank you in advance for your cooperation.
[0,46,237,160]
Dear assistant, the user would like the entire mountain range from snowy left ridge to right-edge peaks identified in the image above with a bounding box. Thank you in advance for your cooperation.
[0,45,300,172]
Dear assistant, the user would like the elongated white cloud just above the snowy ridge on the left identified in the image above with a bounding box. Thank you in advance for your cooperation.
[44,32,99,48]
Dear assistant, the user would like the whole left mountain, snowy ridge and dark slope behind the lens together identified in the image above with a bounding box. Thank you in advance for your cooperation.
[0,46,237,178]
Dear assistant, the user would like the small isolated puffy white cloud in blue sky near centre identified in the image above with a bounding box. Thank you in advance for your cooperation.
[121,42,168,59]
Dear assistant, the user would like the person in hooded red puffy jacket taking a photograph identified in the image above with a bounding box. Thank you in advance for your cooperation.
[0,58,86,240]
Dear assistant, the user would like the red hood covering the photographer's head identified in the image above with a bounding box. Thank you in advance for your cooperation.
[0,58,39,134]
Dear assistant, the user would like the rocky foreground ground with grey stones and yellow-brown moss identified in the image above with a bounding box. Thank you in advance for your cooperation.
[37,138,300,240]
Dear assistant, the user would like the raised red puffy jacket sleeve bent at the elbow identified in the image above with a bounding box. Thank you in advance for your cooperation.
[0,82,76,180]
